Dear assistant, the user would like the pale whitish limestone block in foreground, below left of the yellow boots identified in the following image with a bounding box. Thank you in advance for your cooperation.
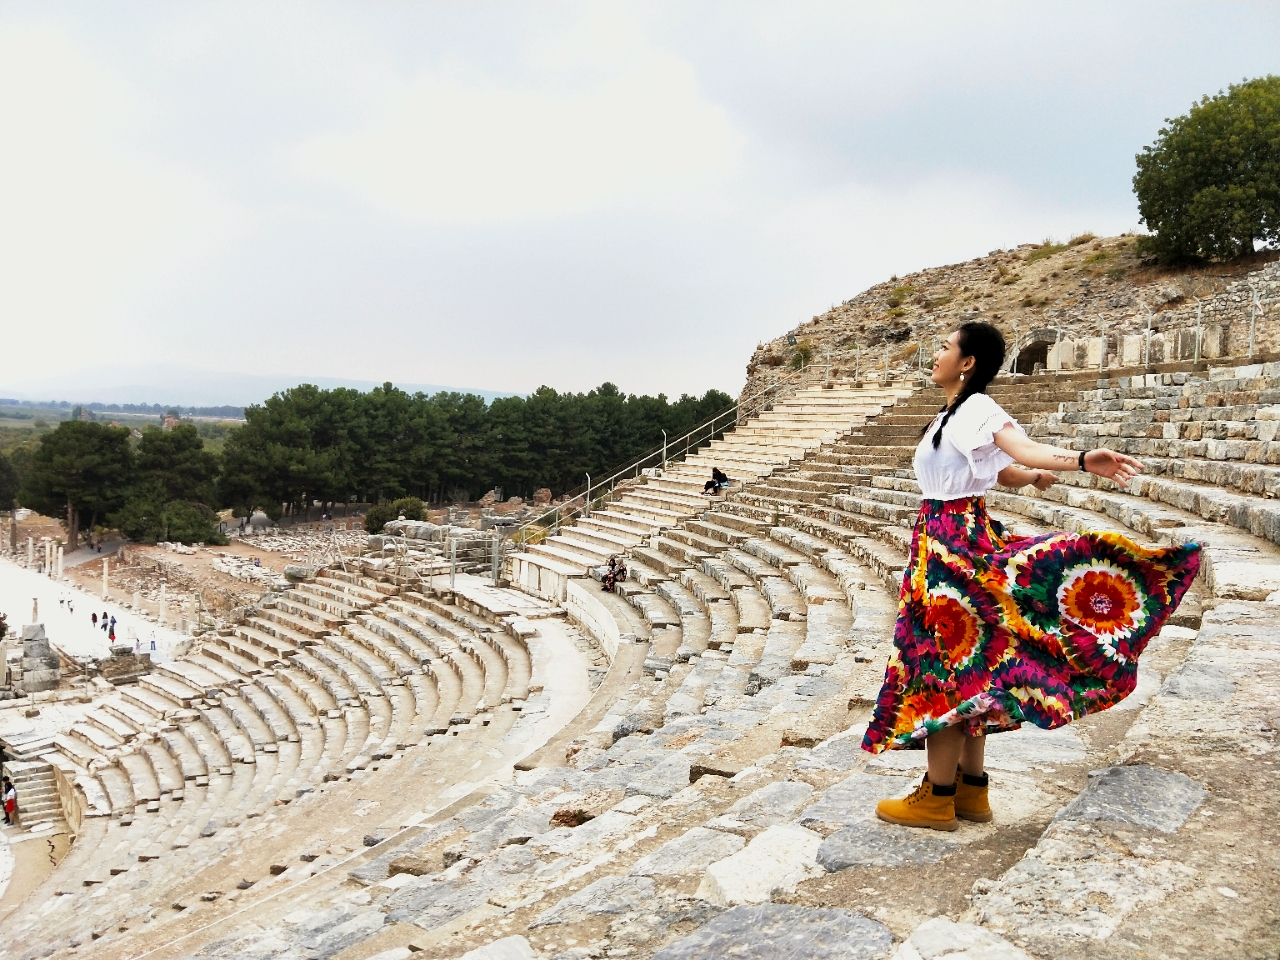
[696,824,823,906]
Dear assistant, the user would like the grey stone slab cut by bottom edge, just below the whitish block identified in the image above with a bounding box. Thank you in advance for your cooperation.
[653,904,893,960]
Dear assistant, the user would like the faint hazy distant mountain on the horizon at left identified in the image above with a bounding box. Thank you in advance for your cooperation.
[0,364,518,407]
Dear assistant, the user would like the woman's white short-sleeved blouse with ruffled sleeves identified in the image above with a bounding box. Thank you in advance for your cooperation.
[913,393,1023,500]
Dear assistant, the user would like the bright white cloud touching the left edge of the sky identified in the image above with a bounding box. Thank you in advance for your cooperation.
[0,24,247,362]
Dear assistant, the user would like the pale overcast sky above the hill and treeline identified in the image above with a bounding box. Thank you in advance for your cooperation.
[0,0,1280,402]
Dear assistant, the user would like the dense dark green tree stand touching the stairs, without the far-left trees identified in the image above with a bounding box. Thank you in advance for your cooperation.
[221,383,732,518]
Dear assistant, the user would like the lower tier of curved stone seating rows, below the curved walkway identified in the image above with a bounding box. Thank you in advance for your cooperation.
[13,576,545,952]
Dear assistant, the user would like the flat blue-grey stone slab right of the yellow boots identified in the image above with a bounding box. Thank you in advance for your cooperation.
[1055,764,1208,833]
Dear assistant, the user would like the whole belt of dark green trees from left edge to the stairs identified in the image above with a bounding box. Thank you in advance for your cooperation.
[0,383,733,543]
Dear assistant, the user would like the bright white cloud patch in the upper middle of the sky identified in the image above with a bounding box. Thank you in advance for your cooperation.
[291,10,744,223]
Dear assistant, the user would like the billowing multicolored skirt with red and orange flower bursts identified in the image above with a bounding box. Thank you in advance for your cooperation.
[863,497,1201,753]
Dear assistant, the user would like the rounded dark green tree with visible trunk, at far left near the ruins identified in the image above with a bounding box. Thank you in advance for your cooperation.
[19,420,132,550]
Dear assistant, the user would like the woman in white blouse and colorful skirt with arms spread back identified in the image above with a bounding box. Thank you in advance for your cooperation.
[863,323,1201,829]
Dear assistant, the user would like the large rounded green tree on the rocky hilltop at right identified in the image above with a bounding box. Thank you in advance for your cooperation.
[1133,77,1280,262]
